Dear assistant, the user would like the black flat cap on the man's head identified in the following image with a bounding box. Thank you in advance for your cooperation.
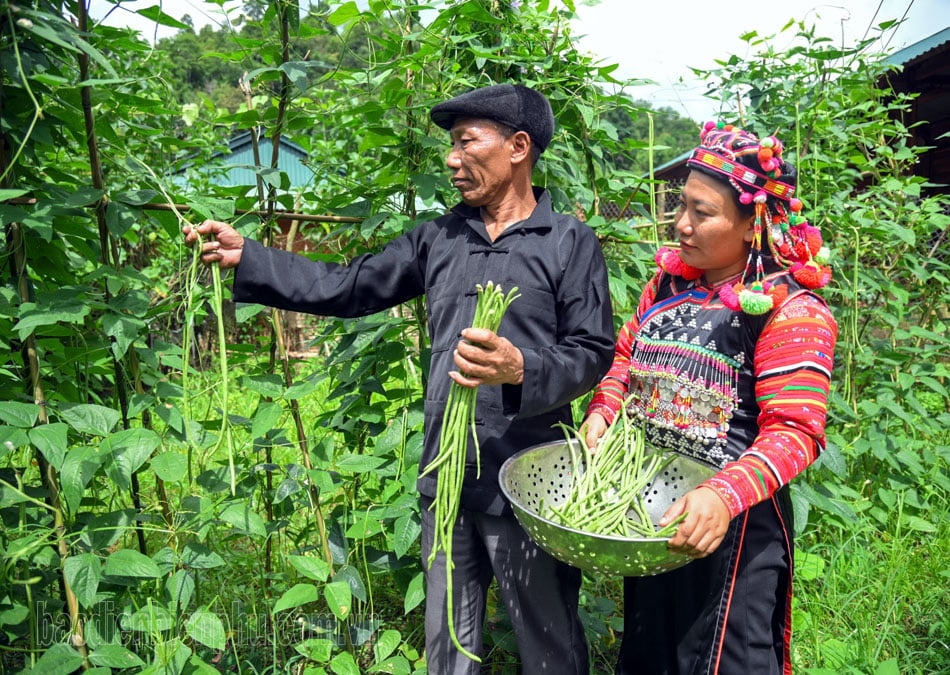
[429,84,554,151]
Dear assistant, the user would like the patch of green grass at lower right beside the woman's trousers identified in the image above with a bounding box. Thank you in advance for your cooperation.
[793,501,950,675]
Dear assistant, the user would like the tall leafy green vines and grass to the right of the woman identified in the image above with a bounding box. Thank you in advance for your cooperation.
[706,21,950,674]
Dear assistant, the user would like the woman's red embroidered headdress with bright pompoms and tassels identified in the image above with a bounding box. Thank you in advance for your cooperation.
[656,122,831,314]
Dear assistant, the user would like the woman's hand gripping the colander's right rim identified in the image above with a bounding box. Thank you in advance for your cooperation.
[659,486,732,558]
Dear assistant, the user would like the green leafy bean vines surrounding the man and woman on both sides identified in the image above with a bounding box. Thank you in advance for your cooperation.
[0,0,950,673]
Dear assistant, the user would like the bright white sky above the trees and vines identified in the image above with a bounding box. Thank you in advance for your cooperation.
[90,0,950,122]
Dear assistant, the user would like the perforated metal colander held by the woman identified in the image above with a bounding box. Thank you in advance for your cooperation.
[498,440,715,577]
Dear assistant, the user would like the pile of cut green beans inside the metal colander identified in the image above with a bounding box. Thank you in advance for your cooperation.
[542,410,685,538]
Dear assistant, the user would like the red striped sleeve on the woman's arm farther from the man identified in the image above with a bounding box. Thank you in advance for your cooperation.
[703,293,838,517]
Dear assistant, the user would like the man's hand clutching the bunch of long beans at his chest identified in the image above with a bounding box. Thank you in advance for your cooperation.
[449,328,524,387]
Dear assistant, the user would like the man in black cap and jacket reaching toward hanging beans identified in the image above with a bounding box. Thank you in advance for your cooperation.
[185,84,614,675]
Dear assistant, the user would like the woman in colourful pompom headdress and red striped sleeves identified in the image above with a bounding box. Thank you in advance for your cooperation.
[585,123,837,675]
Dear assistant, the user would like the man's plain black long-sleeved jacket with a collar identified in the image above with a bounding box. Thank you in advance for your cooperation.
[234,188,614,515]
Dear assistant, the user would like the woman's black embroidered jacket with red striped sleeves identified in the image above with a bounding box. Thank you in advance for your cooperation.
[587,273,837,517]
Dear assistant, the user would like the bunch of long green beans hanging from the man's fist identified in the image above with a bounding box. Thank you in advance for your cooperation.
[421,281,518,662]
